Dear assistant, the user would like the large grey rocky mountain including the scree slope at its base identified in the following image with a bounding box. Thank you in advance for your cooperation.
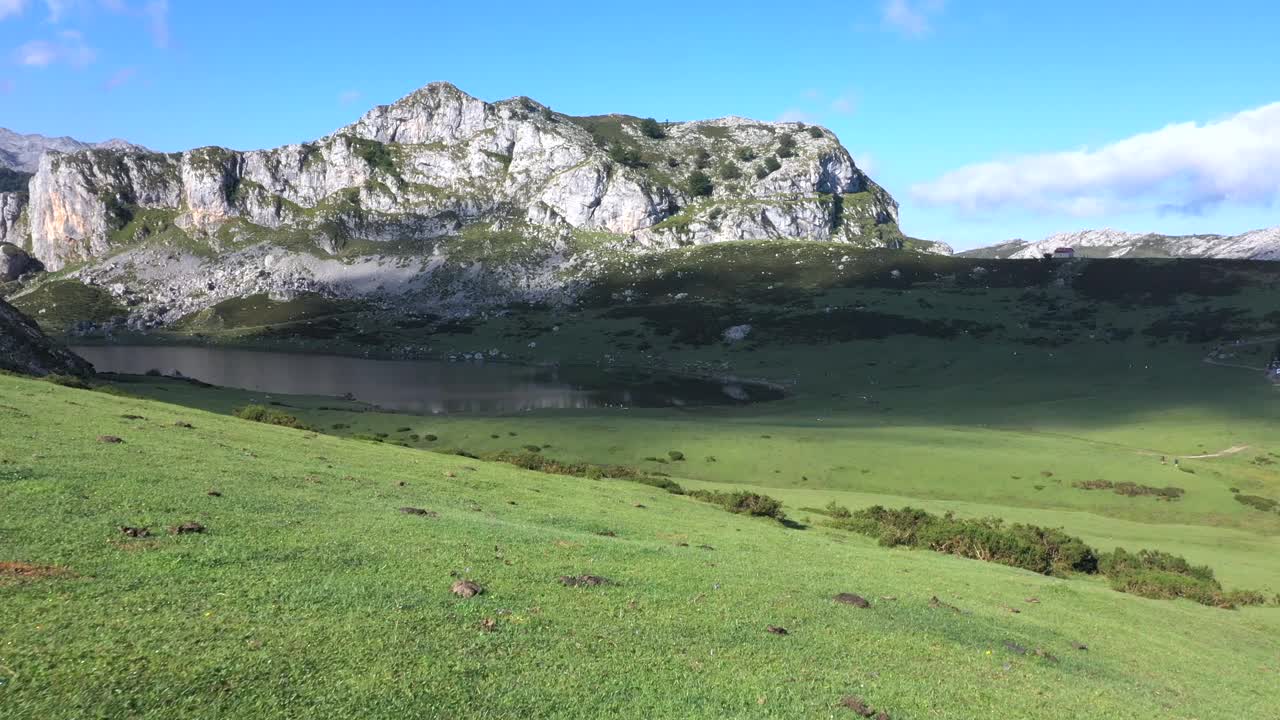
[0,83,945,323]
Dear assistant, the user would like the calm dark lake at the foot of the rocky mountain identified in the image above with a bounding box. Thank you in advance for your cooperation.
[72,346,782,414]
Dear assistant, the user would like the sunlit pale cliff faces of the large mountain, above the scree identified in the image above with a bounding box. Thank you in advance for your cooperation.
[20,78,901,270]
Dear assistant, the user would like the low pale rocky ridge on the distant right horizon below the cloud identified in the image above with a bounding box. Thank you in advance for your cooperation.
[959,227,1280,260]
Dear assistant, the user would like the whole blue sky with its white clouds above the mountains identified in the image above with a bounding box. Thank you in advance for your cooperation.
[0,0,1280,247]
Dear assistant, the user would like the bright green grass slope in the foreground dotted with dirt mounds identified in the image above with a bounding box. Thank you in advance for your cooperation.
[0,368,1280,720]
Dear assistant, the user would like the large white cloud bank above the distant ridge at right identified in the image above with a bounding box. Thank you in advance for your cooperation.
[911,102,1280,217]
